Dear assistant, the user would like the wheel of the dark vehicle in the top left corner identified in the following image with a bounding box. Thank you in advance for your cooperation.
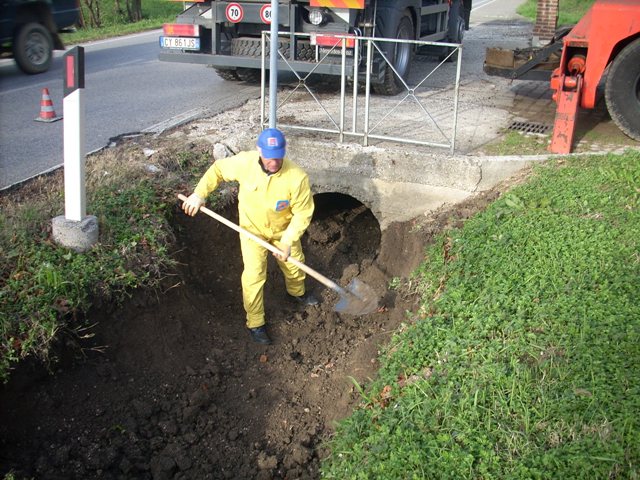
[13,22,53,74]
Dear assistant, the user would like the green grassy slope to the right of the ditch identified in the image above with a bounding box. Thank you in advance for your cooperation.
[322,151,640,479]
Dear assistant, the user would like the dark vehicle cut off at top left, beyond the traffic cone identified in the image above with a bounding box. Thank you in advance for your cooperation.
[0,0,80,74]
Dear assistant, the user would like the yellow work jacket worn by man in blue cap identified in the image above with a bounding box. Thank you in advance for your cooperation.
[195,151,314,245]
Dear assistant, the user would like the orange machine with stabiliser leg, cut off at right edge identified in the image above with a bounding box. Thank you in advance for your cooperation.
[549,0,640,153]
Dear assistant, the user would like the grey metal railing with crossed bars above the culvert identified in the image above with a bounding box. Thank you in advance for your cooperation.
[261,31,462,154]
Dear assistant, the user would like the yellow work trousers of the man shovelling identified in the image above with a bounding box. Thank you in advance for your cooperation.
[240,235,306,328]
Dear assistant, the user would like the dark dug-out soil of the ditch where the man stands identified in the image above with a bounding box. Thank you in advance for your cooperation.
[0,186,504,479]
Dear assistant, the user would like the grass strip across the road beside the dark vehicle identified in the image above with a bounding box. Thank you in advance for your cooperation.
[62,0,182,46]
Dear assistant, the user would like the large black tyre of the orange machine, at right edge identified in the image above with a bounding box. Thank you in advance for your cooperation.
[604,39,640,142]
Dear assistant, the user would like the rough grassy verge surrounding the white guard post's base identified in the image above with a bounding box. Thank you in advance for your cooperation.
[0,140,211,380]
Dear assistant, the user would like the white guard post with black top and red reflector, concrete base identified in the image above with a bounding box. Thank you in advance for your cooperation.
[52,47,98,252]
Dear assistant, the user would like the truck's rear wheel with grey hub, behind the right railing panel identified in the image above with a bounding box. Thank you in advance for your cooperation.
[372,14,415,95]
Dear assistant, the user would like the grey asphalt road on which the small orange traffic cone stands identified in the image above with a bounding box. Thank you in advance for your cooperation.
[0,31,260,189]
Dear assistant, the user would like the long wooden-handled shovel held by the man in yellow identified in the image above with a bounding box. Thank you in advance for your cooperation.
[178,194,378,315]
